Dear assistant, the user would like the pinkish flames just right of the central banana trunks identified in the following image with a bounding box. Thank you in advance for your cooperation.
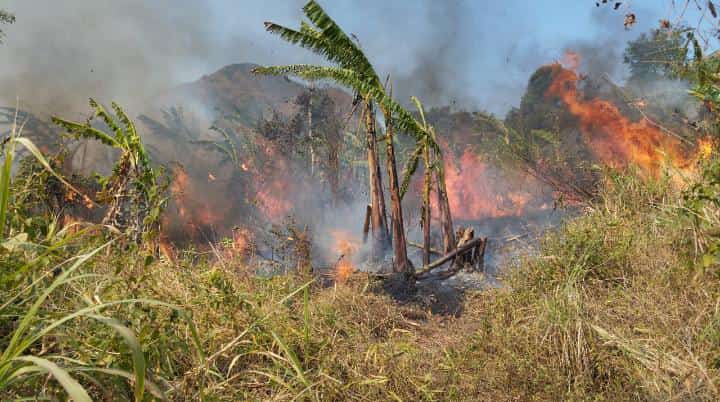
[442,148,543,220]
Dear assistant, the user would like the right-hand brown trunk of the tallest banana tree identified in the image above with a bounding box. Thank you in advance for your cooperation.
[383,111,412,277]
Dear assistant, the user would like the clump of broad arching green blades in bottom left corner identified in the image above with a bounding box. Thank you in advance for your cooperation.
[0,238,202,402]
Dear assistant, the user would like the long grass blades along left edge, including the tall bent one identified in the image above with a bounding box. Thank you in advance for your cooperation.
[0,109,203,402]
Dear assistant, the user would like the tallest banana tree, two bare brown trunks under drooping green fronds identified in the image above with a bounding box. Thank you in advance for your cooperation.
[255,1,418,273]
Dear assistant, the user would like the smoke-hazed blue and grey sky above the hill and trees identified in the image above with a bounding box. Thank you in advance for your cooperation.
[0,0,708,115]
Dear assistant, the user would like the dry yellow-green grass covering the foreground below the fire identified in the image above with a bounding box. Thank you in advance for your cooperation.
[5,177,720,401]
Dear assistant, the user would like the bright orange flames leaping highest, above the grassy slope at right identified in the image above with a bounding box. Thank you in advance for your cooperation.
[546,59,696,177]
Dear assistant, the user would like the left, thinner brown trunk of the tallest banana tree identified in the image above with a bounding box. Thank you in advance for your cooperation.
[365,101,387,260]
